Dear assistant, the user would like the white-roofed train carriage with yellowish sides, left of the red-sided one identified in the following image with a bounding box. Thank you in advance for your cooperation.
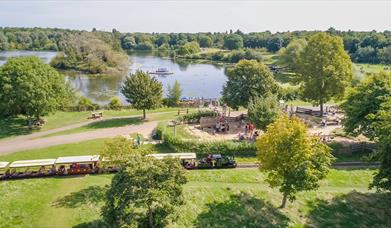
[8,159,56,177]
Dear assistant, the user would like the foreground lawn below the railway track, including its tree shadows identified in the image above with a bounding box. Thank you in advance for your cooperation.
[0,169,391,227]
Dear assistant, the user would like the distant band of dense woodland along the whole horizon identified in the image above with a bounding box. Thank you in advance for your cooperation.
[0,28,391,65]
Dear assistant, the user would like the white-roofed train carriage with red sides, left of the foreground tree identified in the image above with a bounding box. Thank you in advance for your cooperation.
[55,155,100,175]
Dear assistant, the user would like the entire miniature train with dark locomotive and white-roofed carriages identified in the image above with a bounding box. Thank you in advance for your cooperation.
[0,153,236,180]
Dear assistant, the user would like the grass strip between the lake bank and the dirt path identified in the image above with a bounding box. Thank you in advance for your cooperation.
[0,108,188,140]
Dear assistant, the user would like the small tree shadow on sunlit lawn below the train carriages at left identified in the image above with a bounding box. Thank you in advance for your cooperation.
[53,185,107,208]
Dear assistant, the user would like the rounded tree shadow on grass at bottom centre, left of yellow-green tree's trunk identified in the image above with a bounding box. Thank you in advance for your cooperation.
[196,192,289,228]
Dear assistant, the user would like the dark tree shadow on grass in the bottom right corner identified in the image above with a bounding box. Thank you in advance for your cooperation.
[307,191,391,227]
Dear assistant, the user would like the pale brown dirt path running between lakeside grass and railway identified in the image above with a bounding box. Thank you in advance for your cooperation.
[0,117,158,154]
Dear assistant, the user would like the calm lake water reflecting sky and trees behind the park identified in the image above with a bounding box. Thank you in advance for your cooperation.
[0,51,227,104]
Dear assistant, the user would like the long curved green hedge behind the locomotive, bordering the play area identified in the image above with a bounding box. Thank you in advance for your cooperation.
[155,123,257,157]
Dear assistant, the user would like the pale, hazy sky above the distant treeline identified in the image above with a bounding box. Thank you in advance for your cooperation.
[0,0,391,32]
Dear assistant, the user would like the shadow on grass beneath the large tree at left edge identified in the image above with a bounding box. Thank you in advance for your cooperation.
[0,117,32,139]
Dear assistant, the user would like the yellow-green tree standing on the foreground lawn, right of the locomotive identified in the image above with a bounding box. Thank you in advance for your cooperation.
[256,115,333,208]
